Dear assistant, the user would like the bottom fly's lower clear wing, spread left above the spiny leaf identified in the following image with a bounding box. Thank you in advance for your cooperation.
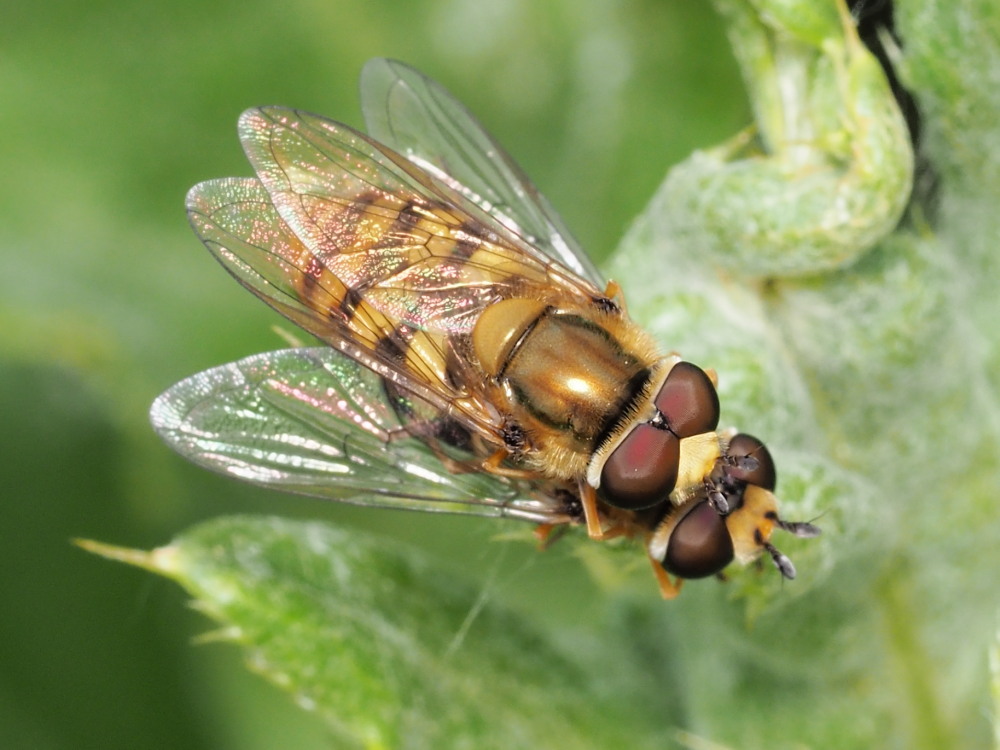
[150,348,570,523]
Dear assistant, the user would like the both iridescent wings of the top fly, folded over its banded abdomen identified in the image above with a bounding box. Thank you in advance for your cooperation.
[188,108,602,446]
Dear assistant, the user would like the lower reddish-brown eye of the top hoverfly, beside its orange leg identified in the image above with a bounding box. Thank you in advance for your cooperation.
[598,423,681,510]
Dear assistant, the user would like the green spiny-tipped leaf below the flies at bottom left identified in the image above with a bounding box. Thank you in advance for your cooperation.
[84,517,662,748]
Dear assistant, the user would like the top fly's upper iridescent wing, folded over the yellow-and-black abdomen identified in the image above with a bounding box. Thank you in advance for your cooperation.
[240,107,603,308]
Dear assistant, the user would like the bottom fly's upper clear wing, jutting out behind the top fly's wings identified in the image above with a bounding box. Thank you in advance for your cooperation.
[361,58,606,289]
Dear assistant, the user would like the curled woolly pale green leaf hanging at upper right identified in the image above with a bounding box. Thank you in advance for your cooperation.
[659,0,913,278]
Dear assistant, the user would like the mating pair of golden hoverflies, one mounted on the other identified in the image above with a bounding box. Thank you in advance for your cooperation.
[151,59,817,598]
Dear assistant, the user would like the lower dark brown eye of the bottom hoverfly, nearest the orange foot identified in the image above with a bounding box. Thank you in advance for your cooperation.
[663,500,733,578]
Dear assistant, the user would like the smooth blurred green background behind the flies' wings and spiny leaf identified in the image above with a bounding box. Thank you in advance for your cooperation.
[0,0,749,750]
